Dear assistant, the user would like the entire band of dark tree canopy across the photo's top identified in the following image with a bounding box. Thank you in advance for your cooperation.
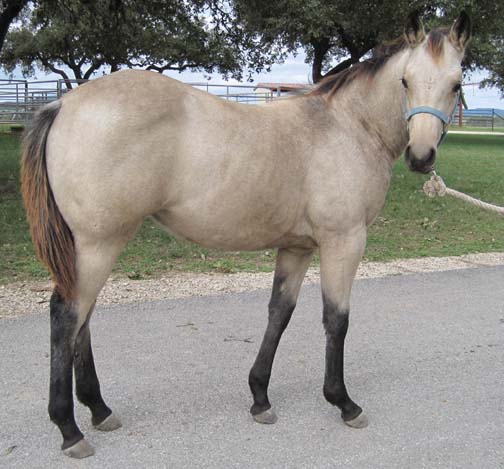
[0,0,504,93]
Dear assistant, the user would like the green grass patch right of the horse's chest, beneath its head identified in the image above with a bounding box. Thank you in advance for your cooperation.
[366,134,504,260]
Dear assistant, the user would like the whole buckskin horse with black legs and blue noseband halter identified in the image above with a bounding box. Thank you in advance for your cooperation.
[21,12,471,458]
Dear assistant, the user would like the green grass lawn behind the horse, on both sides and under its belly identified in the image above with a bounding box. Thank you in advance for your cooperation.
[0,133,504,283]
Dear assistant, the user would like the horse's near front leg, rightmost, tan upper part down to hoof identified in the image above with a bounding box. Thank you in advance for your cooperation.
[320,227,368,428]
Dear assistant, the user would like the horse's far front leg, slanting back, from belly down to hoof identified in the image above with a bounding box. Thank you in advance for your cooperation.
[249,249,313,423]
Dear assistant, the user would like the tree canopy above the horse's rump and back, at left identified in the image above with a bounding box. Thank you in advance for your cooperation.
[1,0,274,86]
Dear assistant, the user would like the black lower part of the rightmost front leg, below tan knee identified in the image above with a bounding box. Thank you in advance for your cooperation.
[323,298,362,421]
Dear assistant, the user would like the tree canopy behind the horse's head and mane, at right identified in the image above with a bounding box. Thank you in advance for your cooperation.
[231,0,504,90]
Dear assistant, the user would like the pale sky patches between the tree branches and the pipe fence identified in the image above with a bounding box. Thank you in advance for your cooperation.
[0,51,504,109]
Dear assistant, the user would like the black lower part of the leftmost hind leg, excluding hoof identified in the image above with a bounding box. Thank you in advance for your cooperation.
[48,291,84,449]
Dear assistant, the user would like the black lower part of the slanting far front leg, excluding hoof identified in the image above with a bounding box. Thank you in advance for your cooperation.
[249,276,296,415]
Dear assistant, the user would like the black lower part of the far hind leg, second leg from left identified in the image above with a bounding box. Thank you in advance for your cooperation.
[74,322,112,425]
